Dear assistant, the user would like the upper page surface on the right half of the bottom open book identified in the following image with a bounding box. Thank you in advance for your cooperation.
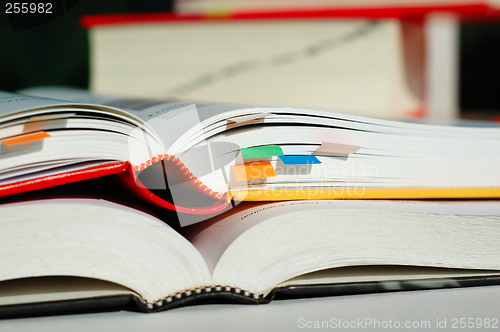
[187,200,500,272]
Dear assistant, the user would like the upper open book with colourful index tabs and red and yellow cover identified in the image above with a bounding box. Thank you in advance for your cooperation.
[0,89,500,223]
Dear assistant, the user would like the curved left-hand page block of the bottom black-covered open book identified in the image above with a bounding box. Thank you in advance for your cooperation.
[0,199,210,304]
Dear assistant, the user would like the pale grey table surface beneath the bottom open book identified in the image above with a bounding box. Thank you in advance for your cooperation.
[0,286,500,332]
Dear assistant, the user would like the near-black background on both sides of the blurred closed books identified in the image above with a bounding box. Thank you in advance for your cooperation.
[0,0,500,117]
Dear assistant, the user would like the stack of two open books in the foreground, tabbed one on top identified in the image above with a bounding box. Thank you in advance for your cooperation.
[0,88,500,317]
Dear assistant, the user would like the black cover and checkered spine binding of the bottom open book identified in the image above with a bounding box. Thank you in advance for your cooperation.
[0,276,500,319]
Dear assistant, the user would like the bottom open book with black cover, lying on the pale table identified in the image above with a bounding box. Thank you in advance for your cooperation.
[0,199,500,316]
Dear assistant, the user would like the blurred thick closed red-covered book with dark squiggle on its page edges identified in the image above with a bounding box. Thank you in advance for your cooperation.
[82,12,422,118]
